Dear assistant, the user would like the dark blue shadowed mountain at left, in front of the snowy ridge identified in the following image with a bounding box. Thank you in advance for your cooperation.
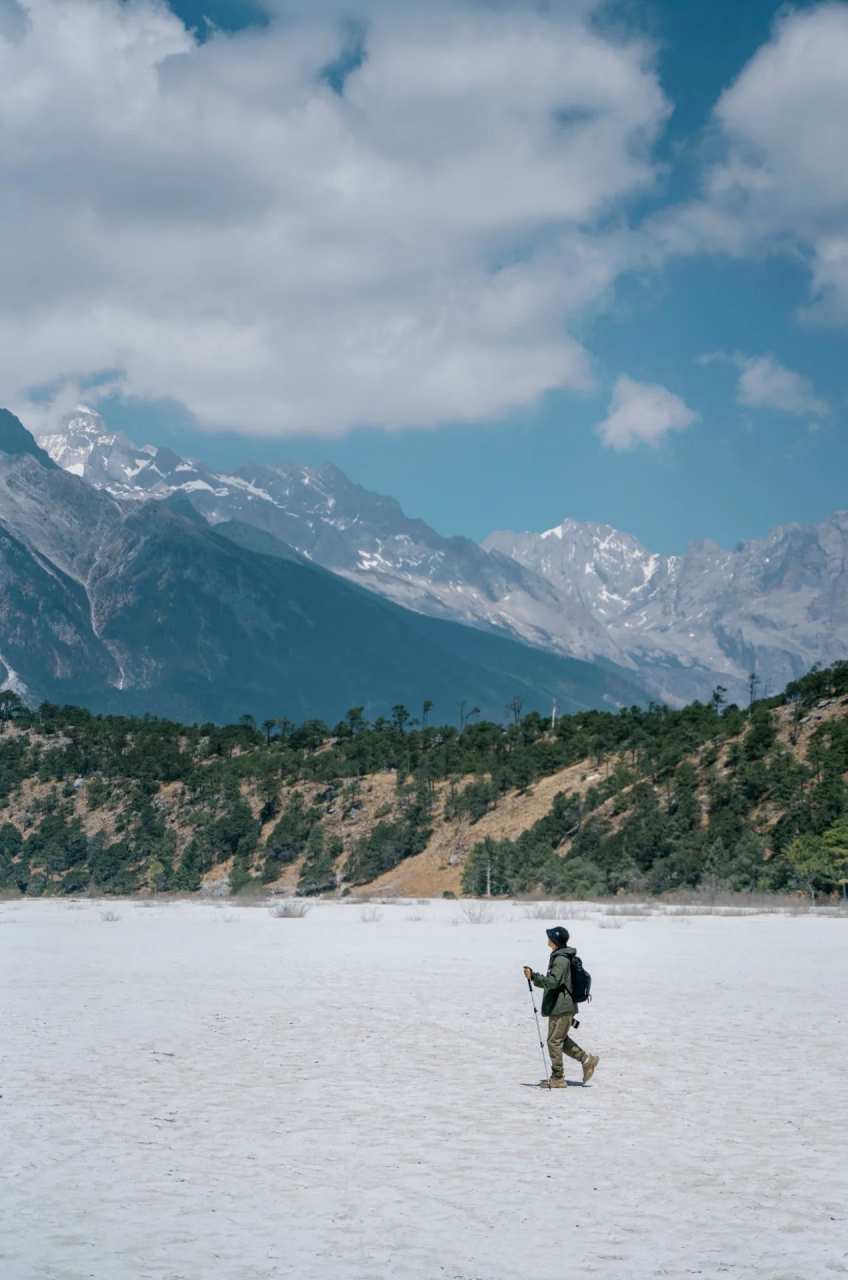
[0,411,640,723]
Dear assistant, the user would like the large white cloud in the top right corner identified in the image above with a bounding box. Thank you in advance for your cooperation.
[657,3,848,323]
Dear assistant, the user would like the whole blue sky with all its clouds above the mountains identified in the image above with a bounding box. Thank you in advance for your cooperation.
[0,0,848,552]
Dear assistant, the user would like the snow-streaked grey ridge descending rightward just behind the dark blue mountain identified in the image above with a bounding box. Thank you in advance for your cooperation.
[33,407,632,666]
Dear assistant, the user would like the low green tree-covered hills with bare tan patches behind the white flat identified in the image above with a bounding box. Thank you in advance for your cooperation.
[0,663,848,897]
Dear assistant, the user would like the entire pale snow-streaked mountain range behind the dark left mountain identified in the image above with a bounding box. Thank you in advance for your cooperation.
[34,408,848,704]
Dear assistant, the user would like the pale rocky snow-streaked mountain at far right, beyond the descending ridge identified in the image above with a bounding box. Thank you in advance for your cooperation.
[483,512,848,699]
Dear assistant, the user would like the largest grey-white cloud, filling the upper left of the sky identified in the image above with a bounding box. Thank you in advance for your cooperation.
[0,0,667,434]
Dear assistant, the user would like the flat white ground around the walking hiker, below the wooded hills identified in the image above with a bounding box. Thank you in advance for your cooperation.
[0,901,848,1280]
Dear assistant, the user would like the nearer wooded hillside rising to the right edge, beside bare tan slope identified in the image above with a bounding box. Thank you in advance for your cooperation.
[464,663,848,899]
